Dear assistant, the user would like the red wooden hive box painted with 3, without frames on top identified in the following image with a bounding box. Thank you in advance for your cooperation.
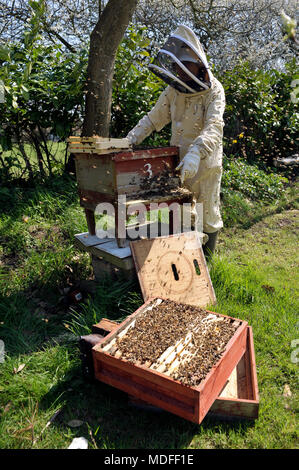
[73,147,192,247]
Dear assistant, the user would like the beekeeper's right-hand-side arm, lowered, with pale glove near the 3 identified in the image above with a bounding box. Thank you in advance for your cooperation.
[177,85,225,182]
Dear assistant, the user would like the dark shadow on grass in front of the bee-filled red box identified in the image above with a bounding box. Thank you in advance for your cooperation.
[40,367,253,449]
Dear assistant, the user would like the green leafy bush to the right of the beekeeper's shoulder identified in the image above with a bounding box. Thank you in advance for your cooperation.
[219,61,299,168]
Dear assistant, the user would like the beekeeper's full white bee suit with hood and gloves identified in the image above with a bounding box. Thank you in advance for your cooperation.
[127,25,225,234]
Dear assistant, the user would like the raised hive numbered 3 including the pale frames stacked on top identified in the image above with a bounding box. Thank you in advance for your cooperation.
[69,136,192,247]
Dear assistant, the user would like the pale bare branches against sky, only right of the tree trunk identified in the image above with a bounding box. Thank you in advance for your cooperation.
[135,0,298,70]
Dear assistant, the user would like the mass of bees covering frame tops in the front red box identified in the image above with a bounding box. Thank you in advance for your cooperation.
[105,299,239,386]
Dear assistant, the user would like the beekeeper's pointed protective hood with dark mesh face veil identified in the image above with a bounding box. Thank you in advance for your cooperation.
[149,25,212,93]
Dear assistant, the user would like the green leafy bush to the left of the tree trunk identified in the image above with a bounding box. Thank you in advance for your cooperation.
[0,1,87,180]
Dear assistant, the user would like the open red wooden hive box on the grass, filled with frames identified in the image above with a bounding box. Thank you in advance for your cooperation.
[93,299,247,424]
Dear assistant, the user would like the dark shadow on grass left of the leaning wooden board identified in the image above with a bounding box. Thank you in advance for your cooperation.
[0,274,142,357]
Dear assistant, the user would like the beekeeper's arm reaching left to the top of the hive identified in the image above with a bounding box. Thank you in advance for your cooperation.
[127,87,171,145]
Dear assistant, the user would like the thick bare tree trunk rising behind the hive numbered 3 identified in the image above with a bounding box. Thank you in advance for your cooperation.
[82,0,138,137]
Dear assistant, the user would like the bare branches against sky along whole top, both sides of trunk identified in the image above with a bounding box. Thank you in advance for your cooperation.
[0,0,298,70]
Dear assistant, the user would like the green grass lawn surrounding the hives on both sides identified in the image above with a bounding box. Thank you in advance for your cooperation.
[0,177,299,449]
